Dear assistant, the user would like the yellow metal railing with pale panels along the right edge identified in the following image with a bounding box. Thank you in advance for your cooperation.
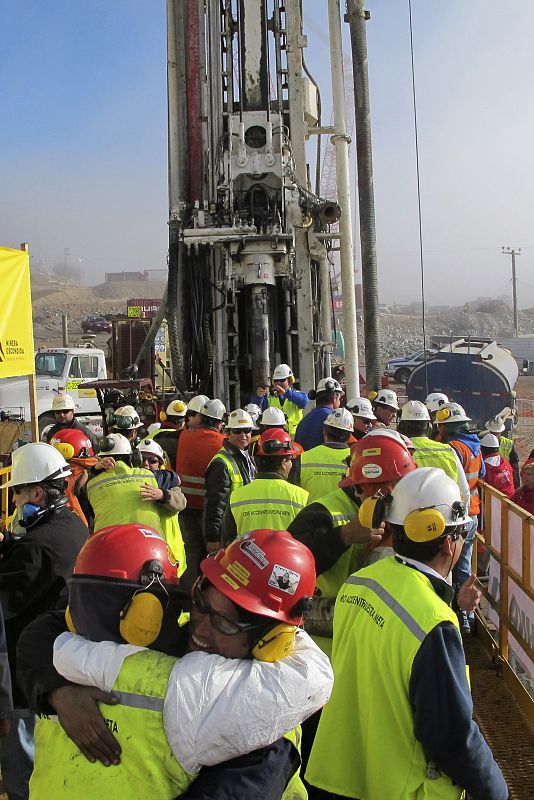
[474,481,534,725]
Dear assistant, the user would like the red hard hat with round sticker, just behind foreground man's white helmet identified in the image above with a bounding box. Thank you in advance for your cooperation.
[339,434,417,488]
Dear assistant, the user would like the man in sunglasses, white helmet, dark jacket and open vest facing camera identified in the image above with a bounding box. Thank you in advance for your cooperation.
[202,408,256,553]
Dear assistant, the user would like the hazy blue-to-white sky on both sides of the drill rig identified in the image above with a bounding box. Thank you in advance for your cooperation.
[0,0,534,306]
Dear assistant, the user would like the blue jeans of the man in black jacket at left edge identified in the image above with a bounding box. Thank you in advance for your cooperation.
[0,709,35,800]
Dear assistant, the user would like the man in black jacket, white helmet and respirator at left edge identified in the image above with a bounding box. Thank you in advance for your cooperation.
[0,442,89,800]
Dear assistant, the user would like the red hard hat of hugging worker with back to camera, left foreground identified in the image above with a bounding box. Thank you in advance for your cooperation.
[72,525,178,585]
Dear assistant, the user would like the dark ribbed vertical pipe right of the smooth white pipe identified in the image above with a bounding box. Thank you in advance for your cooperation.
[345,0,382,391]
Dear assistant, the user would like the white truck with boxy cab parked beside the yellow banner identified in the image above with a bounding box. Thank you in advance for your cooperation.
[0,347,107,435]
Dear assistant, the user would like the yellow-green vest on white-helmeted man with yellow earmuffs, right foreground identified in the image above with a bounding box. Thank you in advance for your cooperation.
[306,556,463,800]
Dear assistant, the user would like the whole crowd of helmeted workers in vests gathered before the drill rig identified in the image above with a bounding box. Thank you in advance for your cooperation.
[0,364,534,800]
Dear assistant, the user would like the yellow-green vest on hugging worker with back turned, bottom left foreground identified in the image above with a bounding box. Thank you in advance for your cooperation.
[30,650,195,800]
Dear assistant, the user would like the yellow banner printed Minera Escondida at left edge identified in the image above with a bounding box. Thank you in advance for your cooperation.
[0,247,35,378]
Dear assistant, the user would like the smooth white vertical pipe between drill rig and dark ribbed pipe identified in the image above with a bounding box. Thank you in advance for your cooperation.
[328,0,360,397]
